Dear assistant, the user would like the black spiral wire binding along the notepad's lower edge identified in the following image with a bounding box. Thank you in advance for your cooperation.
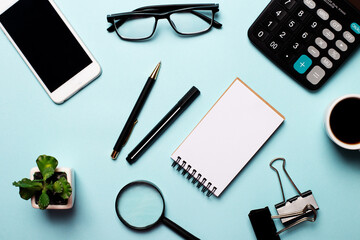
[171,157,217,197]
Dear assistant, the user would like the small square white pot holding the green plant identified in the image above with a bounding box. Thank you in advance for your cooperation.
[30,167,75,210]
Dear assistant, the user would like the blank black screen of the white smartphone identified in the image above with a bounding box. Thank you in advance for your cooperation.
[0,0,92,92]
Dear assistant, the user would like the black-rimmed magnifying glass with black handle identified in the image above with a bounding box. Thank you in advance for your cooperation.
[115,181,199,240]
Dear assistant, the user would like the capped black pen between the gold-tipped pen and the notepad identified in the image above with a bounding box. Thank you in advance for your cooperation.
[126,87,200,164]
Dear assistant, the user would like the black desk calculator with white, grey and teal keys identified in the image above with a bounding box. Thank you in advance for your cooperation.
[248,0,360,90]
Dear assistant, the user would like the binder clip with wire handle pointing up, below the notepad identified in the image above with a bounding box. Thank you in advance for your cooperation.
[270,158,319,225]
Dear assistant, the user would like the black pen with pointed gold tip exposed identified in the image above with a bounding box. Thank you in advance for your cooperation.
[111,62,161,160]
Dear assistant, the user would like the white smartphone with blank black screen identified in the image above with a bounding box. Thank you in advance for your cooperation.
[0,0,101,104]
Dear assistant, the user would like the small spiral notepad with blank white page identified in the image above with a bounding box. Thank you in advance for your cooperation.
[171,79,285,197]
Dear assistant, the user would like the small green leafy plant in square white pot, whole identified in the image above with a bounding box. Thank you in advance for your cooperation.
[13,155,75,209]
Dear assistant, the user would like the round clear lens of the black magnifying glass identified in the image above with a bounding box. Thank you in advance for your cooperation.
[116,185,164,228]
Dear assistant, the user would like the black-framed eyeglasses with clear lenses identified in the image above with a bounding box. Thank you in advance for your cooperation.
[107,4,222,41]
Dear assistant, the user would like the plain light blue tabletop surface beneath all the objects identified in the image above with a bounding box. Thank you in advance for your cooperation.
[0,0,360,240]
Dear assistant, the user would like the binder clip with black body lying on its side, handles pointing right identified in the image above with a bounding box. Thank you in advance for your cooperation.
[249,205,317,240]
